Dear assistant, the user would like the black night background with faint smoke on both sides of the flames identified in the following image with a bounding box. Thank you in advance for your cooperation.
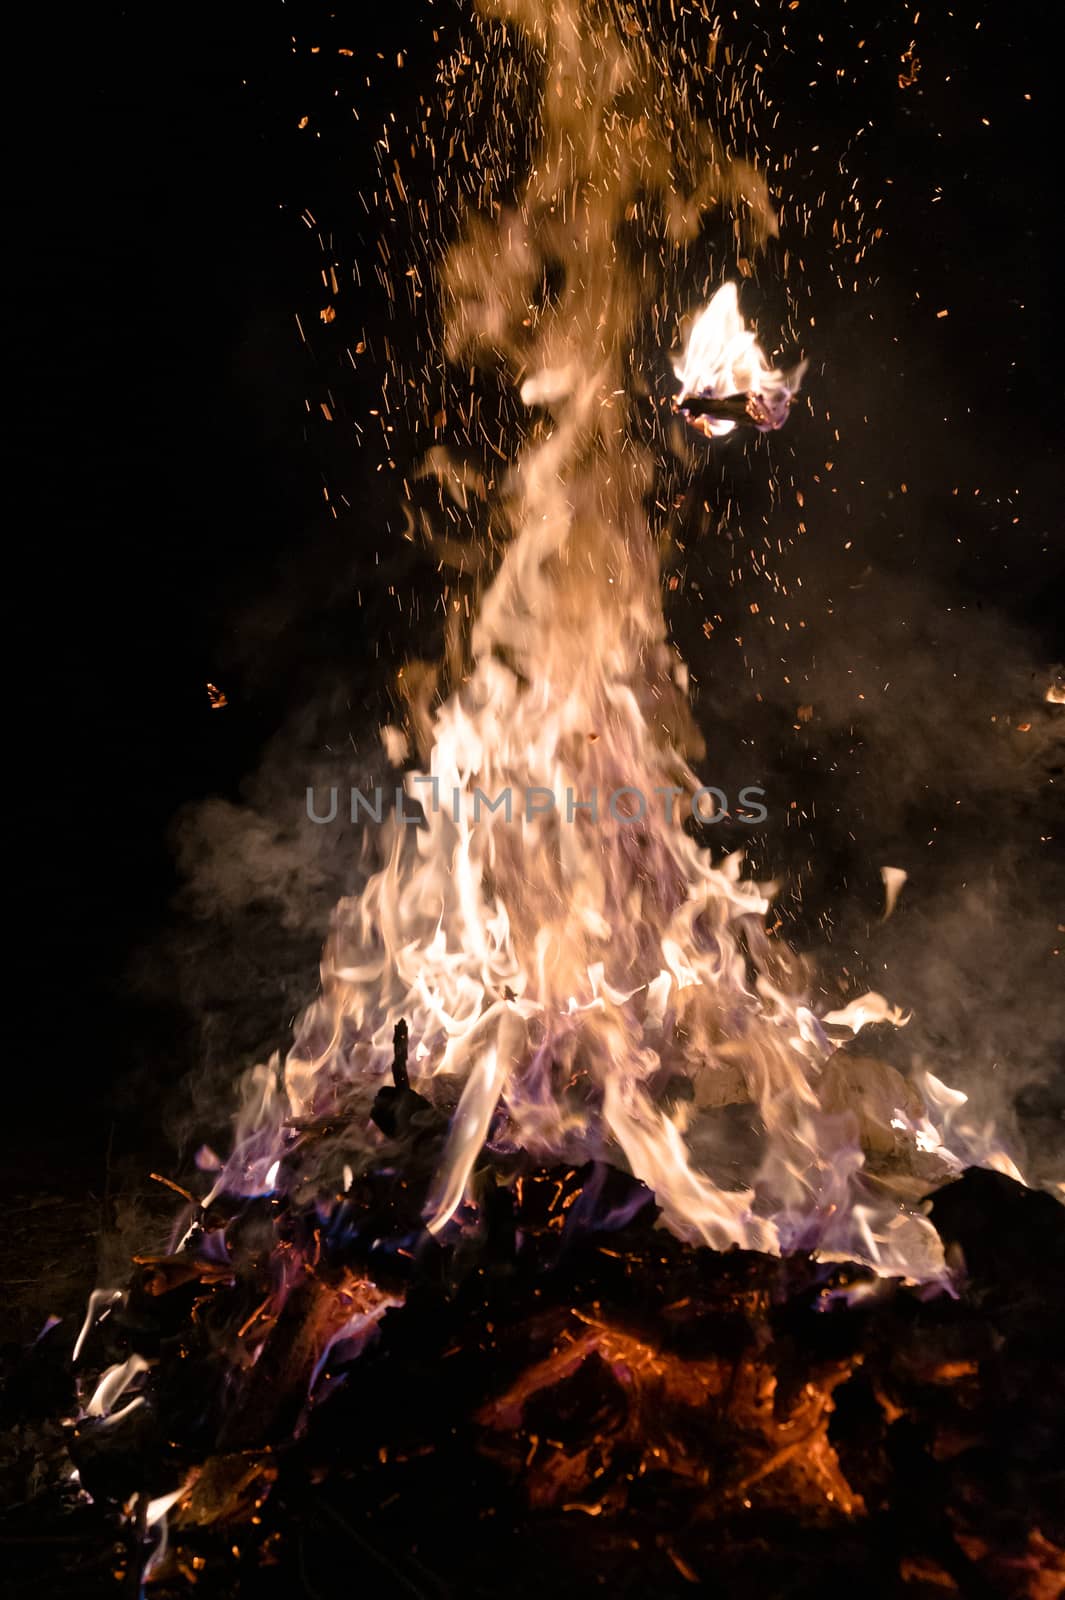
[6,0,1065,1286]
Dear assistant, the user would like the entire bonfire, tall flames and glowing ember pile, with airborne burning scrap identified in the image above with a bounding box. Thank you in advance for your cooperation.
[64,0,1055,1594]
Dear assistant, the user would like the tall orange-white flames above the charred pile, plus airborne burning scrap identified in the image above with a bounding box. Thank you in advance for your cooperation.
[207,0,1010,1278]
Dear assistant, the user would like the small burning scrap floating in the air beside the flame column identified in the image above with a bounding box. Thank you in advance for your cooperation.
[673,283,806,438]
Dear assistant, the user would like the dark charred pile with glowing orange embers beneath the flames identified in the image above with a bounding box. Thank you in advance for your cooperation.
[12,1166,1042,1600]
